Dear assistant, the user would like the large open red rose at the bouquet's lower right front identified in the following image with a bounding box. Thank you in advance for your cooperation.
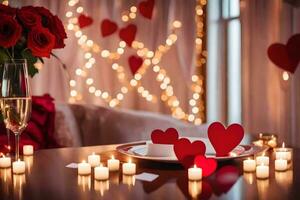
[27,26,55,58]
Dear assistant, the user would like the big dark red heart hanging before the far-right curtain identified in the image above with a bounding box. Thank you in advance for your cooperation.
[268,34,300,73]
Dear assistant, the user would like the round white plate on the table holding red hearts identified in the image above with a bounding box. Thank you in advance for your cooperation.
[117,138,267,163]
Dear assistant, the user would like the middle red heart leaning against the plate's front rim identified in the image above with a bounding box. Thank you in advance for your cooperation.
[173,138,206,168]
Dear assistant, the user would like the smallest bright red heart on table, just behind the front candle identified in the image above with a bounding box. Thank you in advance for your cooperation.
[194,155,218,177]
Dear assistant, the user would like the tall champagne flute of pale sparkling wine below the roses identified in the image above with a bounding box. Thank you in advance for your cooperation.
[0,59,31,160]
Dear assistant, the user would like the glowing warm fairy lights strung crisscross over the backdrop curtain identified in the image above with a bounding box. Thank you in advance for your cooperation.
[66,0,207,124]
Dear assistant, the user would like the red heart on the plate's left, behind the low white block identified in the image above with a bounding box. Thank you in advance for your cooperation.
[151,128,179,144]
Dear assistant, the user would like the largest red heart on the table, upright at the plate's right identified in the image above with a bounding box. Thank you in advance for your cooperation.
[208,122,244,156]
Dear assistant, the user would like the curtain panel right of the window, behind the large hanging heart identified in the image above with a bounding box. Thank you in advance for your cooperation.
[241,0,300,147]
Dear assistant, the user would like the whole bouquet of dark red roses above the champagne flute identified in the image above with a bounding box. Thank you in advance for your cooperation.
[0,4,67,76]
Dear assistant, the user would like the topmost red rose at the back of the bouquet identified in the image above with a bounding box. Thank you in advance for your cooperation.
[17,6,42,28]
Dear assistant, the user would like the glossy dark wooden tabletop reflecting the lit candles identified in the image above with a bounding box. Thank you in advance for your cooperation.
[0,145,300,200]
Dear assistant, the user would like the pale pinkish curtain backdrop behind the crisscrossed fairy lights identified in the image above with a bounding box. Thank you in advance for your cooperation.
[10,0,196,116]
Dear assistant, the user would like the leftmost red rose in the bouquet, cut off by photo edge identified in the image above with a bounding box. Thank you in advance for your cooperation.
[0,15,22,48]
